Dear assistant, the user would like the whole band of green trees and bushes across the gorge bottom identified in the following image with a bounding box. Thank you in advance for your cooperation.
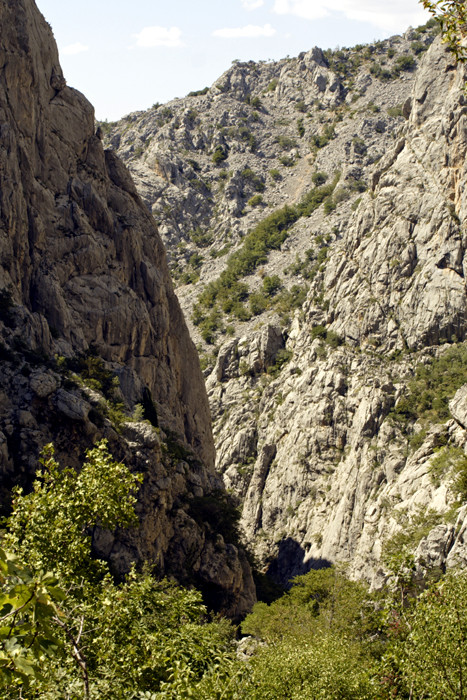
[0,442,467,700]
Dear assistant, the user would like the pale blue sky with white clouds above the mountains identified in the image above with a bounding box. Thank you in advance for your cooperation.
[36,0,429,121]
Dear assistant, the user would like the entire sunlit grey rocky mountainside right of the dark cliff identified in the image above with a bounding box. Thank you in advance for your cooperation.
[107,21,467,585]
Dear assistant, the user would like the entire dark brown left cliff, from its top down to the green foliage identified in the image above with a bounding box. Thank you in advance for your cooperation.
[0,0,254,614]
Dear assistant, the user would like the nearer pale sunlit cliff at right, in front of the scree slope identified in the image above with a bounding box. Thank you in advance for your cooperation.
[208,38,467,584]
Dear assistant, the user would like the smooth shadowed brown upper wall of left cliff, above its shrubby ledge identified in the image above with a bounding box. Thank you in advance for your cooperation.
[0,2,214,464]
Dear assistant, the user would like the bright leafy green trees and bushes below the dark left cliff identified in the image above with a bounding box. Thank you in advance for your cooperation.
[0,442,235,700]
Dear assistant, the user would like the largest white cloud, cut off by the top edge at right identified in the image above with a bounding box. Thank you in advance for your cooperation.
[273,0,428,32]
